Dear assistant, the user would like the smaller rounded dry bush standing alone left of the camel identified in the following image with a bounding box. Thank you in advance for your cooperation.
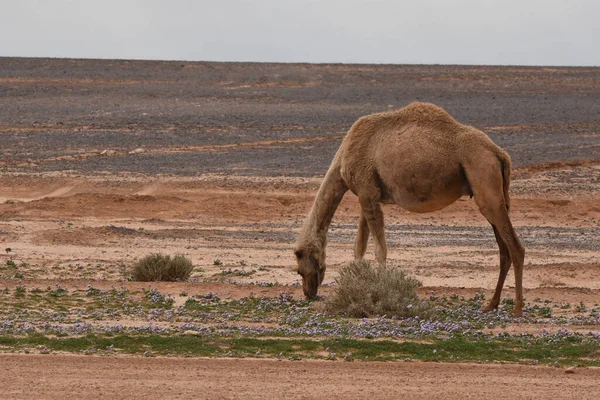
[131,253,194,282]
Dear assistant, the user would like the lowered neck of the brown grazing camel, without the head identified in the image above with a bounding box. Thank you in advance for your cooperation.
[303,157,348,238]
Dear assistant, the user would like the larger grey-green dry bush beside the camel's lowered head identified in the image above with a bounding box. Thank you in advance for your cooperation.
[325,261,432,318]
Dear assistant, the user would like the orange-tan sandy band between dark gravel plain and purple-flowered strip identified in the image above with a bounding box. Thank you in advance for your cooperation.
[0,167,600,294]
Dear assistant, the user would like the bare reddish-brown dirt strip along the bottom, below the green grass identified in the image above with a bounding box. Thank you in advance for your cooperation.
[0,355,600,400]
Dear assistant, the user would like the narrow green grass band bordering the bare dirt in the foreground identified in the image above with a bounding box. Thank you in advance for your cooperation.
[0,335,600,366]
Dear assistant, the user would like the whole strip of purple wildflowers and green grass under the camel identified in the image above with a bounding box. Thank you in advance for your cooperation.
[0,285,600,366]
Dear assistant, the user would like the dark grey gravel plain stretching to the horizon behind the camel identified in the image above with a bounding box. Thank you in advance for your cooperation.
[0,58,600,176]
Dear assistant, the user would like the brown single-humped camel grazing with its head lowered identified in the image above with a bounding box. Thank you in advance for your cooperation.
[294,102,525,316]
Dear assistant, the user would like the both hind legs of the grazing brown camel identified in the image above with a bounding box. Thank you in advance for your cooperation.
[465,159,525,316]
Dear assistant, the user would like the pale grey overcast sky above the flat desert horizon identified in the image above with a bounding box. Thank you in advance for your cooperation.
[0,0,600,66]
